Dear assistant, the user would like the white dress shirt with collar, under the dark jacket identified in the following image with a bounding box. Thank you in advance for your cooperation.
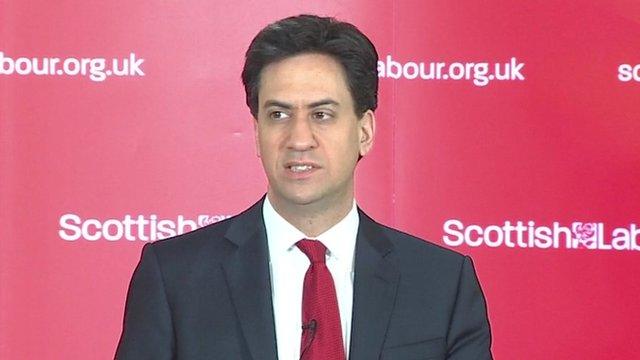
[262,197,360,360]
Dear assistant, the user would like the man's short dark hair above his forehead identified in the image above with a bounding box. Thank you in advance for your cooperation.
[242,15,378,119]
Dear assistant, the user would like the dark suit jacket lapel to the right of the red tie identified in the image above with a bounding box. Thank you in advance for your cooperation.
[349,211,400,360]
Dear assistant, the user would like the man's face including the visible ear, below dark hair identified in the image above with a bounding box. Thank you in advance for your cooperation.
[255,54,375,211]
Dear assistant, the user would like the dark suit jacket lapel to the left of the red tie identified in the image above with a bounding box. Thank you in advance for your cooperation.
[222,198,277,360]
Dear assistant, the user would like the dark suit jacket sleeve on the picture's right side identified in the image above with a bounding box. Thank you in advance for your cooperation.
[447,256,492,360]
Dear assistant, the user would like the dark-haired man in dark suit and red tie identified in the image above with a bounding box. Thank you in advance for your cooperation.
[116,15,491,360]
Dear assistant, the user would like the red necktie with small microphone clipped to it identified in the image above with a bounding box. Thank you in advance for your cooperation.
[296,239,345,360]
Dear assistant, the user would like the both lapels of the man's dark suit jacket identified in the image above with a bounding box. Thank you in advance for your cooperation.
[222,197,400,360]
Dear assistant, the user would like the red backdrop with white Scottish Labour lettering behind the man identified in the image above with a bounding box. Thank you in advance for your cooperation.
[0,0,640,359]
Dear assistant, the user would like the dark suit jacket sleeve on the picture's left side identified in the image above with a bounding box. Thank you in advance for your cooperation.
[115,244,174,360]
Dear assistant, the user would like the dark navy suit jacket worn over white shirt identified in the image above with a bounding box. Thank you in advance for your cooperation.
[116,200,491,360]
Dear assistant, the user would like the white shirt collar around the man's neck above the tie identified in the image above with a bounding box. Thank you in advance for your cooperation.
[262,196,360,267]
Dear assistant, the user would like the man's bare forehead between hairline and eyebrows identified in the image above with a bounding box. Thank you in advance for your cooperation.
[258,54,351,107]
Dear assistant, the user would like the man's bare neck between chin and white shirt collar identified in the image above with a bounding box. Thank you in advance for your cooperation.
[267,192,353,237]
